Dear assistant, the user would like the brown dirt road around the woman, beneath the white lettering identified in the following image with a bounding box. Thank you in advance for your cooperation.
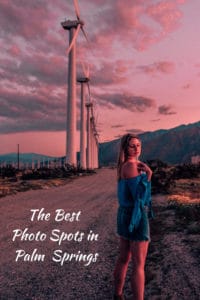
[0,169,200,300]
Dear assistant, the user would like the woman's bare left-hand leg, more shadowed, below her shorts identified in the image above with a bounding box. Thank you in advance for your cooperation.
[114,237,131,295]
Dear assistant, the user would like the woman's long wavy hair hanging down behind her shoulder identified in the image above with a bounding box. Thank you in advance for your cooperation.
[117,133,141,180]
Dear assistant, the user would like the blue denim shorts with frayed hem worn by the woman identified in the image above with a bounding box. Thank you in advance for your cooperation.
[117,206,150,241]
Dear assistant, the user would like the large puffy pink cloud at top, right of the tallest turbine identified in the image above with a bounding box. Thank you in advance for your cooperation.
[91,0,186,51]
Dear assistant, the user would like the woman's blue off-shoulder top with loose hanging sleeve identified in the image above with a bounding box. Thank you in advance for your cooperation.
[117,173,153,232]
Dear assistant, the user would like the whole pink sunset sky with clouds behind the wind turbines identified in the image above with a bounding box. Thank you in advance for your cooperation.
[0,0,200,156]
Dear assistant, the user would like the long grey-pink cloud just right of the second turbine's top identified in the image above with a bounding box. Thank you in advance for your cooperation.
[97,93,156,112]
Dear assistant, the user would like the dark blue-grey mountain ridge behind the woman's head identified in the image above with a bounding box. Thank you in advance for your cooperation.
[99,122,200,166]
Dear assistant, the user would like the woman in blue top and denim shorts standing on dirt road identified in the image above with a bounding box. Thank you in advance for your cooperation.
[114,134,152,300]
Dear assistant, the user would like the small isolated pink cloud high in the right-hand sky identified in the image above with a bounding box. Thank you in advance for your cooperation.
[137,61,175,75]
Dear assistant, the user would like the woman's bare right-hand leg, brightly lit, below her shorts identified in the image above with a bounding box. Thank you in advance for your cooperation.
[131,241,149,300]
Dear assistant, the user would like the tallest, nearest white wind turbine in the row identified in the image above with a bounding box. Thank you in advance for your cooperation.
[61,0,88,166]
